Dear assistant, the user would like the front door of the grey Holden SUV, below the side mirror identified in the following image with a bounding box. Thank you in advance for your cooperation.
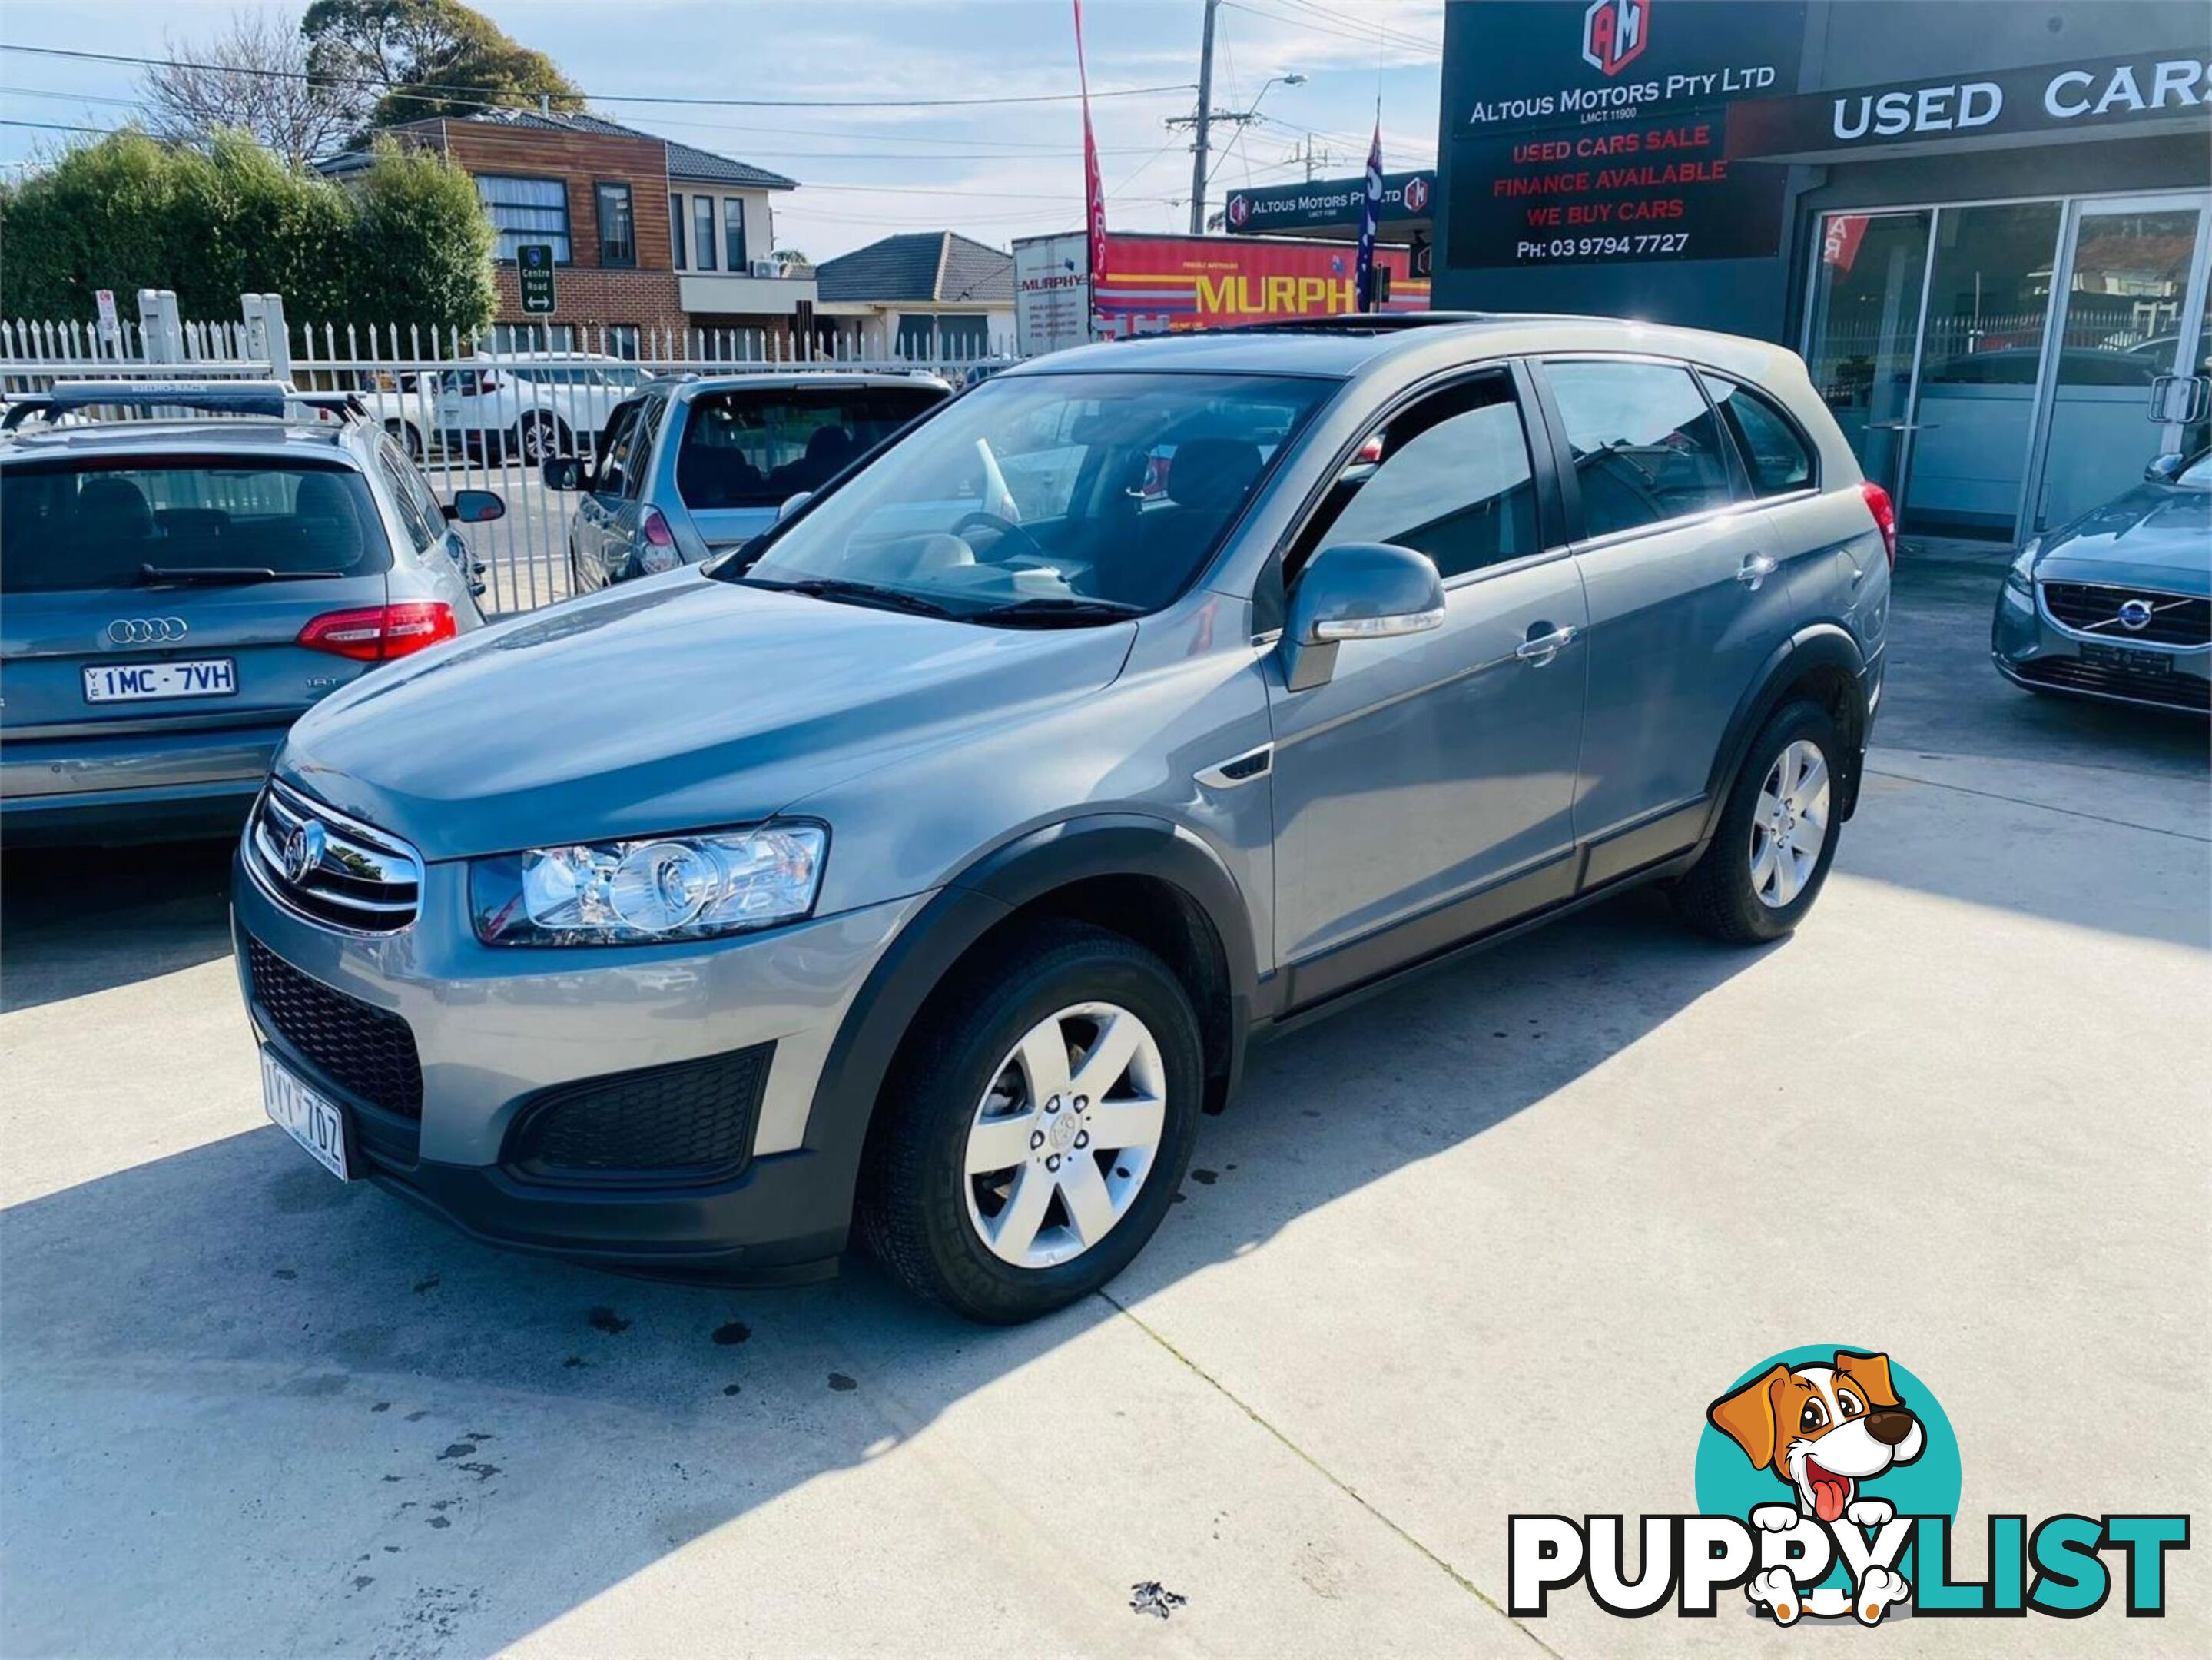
[1270,367,1584,1003]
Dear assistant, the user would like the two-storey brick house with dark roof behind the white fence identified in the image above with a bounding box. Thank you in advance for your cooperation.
[317,108,816,357]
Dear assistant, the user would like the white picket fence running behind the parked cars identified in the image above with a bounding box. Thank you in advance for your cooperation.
[0,310,1013,613]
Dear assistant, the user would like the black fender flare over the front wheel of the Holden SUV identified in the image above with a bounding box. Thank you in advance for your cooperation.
[805,812,1259,1257]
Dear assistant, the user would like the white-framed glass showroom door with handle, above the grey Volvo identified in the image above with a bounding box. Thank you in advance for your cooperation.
[2021,194,2212,533]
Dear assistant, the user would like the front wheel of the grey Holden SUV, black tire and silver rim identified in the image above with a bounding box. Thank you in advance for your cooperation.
[858,921,1205,1326]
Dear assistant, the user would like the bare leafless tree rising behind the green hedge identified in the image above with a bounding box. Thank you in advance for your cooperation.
[139,11,363,166]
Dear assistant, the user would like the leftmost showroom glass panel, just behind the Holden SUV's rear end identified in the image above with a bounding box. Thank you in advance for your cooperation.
[1805,208,1935,496]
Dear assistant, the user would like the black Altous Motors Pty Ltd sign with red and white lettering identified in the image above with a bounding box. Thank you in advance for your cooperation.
[1447,0,1805,270]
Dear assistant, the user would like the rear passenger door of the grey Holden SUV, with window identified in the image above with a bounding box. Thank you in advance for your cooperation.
[1540,359,1794,863]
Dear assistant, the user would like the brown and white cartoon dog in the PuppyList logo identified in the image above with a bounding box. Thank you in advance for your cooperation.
[1706,1350,1927,1625]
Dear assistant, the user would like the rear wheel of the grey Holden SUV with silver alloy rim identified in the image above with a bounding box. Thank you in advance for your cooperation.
[1674,699,1842,945]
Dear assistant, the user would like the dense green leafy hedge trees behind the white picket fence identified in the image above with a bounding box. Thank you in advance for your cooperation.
[0,131,498,330]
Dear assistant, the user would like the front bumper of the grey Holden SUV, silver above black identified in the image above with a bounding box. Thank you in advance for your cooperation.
[232,858,924,1280]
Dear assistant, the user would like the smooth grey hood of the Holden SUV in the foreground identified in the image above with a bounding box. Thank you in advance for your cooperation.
[277,569,1137,861]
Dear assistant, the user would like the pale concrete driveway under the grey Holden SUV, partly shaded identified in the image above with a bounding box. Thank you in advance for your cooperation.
[0,556,2212,1655]
